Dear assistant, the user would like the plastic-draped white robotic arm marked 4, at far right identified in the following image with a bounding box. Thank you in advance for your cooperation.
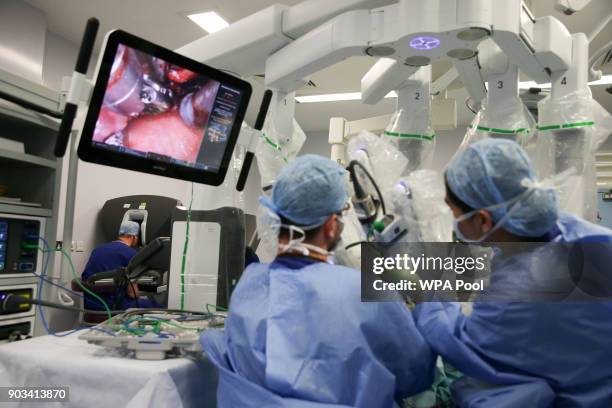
[534,33,612,222]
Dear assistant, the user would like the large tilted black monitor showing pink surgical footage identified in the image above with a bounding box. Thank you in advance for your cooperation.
[78,30,251,185]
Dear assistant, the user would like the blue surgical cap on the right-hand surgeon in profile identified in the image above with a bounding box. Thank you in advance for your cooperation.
[446,139,558,237]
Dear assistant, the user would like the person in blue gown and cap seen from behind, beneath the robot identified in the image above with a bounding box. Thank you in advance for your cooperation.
[201,155,434,408]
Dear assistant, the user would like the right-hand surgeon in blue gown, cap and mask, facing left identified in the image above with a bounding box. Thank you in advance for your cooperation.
[415,139,612,408]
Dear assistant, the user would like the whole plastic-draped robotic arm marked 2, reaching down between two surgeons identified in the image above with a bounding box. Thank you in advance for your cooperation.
[330,67,457,247]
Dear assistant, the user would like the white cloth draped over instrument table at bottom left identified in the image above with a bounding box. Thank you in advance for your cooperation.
[0,332,217,408]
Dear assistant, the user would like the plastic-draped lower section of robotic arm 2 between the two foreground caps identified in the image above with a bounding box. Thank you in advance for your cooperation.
[343,130,452,247]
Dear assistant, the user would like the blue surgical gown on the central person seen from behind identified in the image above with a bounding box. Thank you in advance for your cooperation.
[202,256,435,408]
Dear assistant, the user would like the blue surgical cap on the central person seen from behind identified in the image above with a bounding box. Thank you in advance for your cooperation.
[259,154,348,227]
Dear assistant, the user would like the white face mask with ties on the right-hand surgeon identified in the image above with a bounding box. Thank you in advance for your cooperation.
[453,167,576,243]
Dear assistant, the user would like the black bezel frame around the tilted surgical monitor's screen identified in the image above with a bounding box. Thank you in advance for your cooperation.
[78,30,252,186]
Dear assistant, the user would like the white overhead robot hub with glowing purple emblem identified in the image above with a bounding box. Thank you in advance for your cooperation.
[266,0,572,103]
